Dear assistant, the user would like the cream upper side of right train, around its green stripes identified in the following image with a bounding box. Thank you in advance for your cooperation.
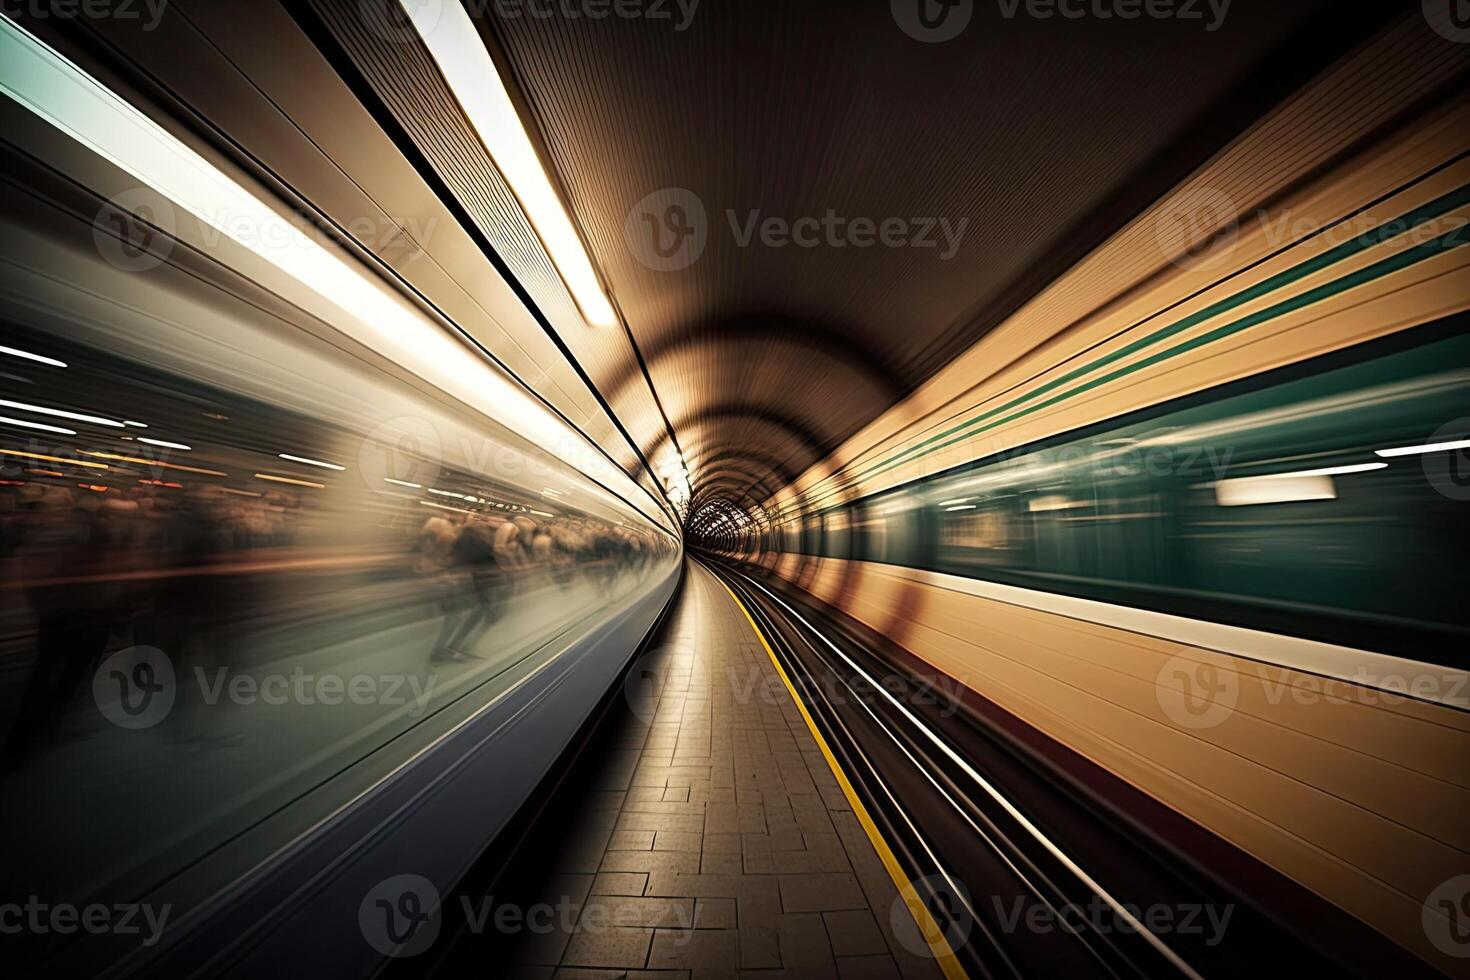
[787,96,1470,517]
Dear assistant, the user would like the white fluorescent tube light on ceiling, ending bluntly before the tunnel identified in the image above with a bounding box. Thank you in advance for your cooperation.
[400,0,617,326]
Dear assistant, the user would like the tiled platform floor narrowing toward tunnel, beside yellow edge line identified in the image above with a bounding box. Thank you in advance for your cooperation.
[492,563,941,980]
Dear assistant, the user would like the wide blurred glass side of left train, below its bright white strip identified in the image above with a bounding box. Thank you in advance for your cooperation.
[0,170,679,934]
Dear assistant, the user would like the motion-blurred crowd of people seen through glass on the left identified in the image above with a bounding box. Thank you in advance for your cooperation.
[0,479,673,768]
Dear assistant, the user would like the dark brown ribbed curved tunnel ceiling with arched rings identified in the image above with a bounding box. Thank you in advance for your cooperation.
[349,0,1388,540]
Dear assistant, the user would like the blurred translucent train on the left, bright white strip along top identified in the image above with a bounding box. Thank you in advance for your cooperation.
[0,18,682,971]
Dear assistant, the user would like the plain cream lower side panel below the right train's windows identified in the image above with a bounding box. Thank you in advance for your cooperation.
[787,558,1470,958]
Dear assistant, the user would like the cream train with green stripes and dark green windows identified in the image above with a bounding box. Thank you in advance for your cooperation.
[700,67,1470,973]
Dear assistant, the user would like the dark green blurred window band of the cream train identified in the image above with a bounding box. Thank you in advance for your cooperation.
[822,329,1470,663]
